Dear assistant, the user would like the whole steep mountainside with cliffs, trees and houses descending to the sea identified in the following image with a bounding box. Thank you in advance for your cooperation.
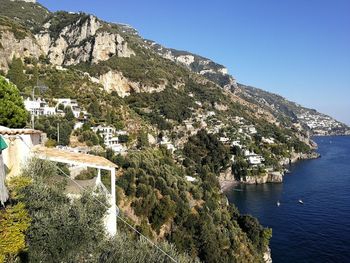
[0,0,347,262]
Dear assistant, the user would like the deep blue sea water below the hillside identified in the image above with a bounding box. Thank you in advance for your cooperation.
[227,136,350,263]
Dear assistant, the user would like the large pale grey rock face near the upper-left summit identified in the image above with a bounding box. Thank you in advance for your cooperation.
[35,13,135,66]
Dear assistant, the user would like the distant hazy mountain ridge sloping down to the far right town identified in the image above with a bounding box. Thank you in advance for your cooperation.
[145,36,350,135]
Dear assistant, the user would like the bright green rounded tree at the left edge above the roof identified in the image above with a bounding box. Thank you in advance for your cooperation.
[0,76,28,128]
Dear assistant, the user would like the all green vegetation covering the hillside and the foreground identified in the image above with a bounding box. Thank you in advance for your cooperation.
[0,0,326,262]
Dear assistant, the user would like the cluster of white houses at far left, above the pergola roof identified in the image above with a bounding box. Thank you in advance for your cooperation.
[24,97,89,119]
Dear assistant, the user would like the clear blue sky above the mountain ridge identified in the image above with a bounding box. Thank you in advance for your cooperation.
[39,0,350,124]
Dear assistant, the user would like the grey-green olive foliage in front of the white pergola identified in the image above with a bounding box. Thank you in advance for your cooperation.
[17,160,106,262]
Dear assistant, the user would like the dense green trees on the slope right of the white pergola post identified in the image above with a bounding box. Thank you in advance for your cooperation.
[116,145,271,262]
